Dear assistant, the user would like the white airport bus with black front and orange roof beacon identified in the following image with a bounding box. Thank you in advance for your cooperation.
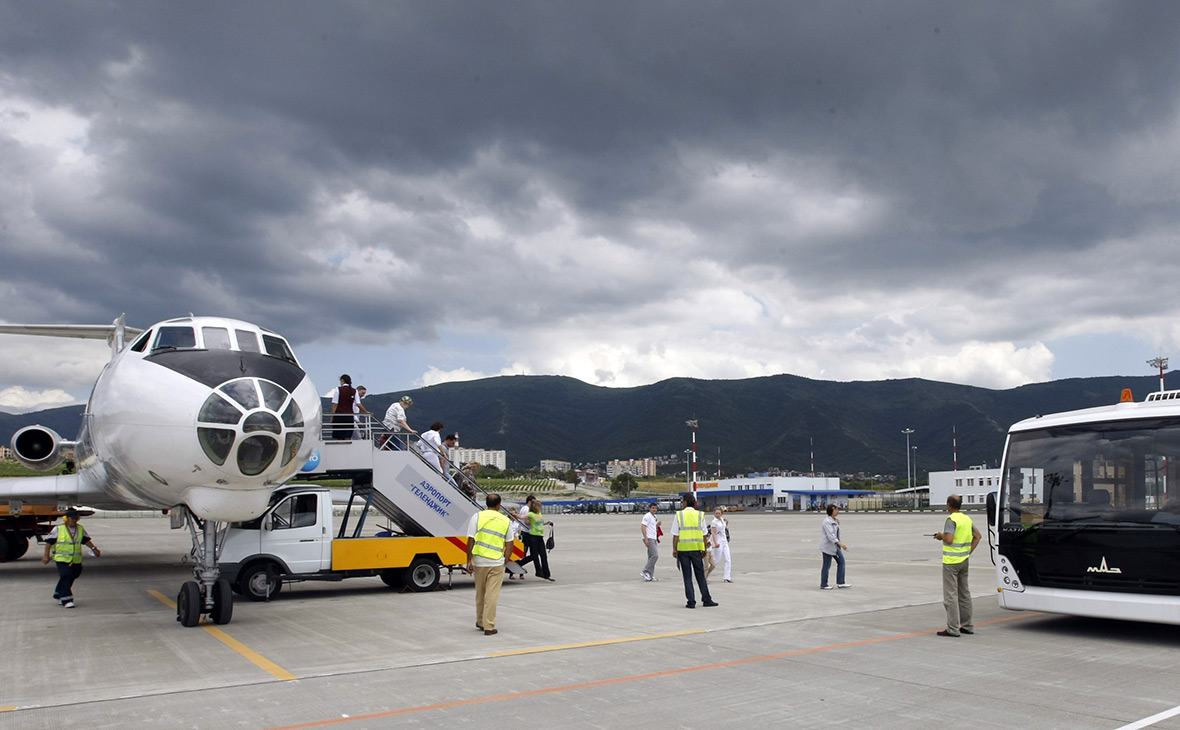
[988,390,1180,624]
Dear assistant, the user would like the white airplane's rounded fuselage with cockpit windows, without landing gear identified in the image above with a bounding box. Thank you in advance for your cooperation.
[0,317,321,521]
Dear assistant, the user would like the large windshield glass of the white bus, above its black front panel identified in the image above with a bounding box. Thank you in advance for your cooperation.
[1001,417,1180,528]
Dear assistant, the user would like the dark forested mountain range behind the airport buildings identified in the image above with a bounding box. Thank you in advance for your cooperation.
[0,373,1173,475]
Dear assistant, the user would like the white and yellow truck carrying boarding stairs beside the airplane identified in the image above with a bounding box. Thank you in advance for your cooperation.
[221,422,524,600]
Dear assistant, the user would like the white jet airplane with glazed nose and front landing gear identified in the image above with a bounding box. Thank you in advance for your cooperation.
[0,315,321,626]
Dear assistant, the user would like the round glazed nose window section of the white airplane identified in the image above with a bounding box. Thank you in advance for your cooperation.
[197,377,306,476]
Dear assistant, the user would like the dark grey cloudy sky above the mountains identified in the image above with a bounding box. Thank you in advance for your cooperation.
[0,0,1180,409]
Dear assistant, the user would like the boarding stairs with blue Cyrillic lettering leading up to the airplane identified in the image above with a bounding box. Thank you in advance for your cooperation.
[299,414,516,537]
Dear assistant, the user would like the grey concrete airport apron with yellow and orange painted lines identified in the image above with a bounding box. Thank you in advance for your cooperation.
[0,513,1180,730]
